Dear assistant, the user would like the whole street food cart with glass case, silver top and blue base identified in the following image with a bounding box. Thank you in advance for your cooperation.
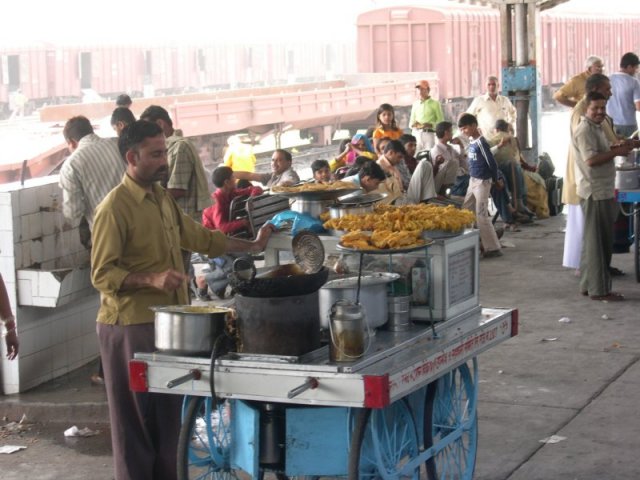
[130,193,518,480]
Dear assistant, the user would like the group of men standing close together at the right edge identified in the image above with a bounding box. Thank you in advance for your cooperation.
[555,52,640,301]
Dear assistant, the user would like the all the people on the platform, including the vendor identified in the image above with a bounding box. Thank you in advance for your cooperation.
[0,53,640,479]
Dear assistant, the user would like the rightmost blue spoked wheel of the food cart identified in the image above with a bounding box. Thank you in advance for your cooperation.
[424,358,478,480]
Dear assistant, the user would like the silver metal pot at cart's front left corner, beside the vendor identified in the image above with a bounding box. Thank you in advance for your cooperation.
[151,305,230,355]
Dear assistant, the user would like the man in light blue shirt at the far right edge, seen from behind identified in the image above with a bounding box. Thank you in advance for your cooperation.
[607,52,640,138]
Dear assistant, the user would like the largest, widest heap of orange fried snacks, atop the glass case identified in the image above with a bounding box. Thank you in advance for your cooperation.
[324,203,475,232]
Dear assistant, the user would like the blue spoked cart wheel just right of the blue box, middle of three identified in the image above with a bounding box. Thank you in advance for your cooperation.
[348,399,420,480]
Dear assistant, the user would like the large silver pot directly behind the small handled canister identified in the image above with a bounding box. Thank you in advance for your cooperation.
[319,272,400,328]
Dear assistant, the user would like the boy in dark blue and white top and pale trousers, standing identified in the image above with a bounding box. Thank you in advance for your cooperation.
[458,113,502,258]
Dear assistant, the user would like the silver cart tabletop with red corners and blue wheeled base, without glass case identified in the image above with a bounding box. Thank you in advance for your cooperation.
[130,309,518,480]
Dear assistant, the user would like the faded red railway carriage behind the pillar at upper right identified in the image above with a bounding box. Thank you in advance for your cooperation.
[357,4,640,98]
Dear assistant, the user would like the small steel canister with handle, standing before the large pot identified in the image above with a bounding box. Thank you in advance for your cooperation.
[329,299,365,362]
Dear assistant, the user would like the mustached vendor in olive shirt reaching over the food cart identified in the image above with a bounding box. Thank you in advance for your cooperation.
[91,121,271,480]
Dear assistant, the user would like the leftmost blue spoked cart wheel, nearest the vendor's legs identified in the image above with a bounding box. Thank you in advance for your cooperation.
[178,397,239,480]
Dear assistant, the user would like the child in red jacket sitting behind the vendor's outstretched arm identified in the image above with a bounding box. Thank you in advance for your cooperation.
[196,166,262,300]
